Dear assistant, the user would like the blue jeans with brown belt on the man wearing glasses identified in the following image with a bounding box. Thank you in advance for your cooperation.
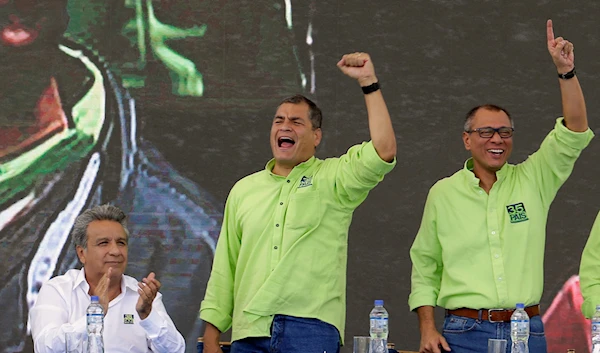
[442,315,546,353]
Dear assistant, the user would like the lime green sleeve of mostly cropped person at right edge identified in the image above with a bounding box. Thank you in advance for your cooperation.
[579,213,600,319]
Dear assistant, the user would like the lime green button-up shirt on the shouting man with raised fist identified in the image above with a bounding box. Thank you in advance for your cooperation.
[200,142,395,341]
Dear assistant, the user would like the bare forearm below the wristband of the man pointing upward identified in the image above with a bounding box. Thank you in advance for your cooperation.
[558,76,588,132]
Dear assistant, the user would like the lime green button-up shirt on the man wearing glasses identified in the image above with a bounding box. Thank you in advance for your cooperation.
[408,118,593,310]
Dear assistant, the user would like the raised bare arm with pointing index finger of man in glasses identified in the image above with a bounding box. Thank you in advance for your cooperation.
[546,20,588,132]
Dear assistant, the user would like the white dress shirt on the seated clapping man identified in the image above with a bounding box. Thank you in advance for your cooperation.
[29,268,185,353]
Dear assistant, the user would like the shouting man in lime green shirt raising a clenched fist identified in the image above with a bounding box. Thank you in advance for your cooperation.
[200,53,396,353]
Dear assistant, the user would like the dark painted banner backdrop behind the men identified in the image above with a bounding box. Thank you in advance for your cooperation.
[0,0,600,352]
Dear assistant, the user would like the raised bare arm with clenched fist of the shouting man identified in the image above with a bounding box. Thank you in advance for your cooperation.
[337,53,396,162]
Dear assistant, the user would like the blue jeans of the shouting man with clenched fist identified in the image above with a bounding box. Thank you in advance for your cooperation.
[231,315,340,353]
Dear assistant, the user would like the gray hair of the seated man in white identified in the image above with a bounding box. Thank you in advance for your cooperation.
[71,204,129,249]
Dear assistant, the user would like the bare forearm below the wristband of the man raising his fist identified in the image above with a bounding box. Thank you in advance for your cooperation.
[361,83,396,162]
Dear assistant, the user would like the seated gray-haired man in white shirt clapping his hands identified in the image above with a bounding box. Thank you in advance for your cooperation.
[29,205,185,353]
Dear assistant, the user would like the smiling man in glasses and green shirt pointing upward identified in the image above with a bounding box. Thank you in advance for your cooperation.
[409,20,593,353]
